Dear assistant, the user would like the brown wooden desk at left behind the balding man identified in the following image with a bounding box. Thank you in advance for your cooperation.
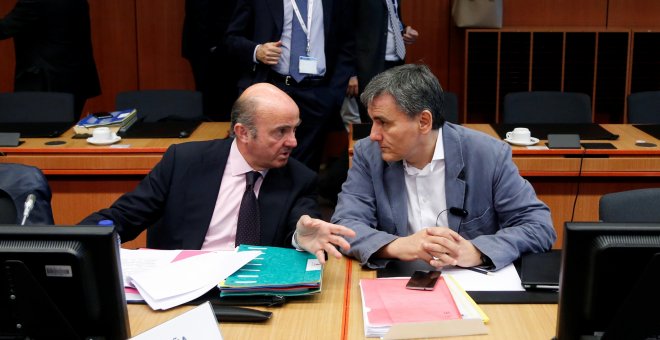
[0,122,229,248]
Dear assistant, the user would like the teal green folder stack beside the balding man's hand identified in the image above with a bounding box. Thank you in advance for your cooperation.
[218,245,323,296]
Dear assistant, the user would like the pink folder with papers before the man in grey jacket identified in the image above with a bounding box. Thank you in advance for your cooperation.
[360,276,487,338]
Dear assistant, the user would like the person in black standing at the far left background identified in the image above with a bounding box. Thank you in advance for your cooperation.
[0,0,101,115]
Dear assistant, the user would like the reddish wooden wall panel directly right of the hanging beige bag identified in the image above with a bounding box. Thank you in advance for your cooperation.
[503,0,604,27]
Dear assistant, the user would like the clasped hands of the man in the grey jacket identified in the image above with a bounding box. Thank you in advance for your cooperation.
[378,227,481,268]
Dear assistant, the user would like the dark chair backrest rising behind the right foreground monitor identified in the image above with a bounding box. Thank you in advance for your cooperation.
[598,188,660,223]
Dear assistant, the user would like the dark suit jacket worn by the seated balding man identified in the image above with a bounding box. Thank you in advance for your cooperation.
[80,139,320,249]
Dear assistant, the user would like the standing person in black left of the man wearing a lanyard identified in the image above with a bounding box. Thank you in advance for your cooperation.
[181,0,238,121]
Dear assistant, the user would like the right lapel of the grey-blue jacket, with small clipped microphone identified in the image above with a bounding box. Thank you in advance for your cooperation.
[442,123,467,231]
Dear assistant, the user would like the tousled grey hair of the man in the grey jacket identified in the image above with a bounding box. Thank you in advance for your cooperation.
[360,64,445,130]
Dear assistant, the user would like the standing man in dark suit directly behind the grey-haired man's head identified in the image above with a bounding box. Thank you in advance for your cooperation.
[349,0,419,122]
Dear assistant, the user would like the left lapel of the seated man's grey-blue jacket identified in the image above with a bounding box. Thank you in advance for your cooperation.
[383,161,408,235]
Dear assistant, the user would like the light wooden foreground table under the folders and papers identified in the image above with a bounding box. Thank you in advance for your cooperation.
[128,258,557,340]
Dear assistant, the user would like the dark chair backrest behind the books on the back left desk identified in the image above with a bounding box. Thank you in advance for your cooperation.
[115,90,204,122]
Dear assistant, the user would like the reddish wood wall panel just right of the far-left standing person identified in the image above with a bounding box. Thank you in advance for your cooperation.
[85,0,138,112]
